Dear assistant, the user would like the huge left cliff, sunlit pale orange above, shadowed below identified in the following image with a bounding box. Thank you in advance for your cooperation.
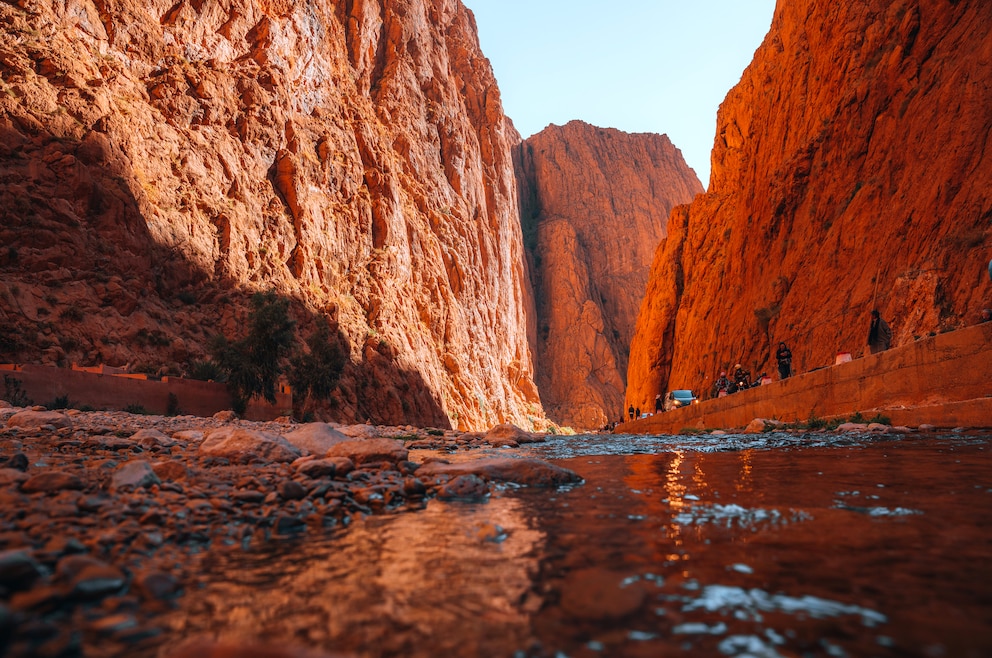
[0,0,543,429]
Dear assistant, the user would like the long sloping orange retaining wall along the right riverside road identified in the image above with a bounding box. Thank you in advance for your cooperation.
[614,322,992,434]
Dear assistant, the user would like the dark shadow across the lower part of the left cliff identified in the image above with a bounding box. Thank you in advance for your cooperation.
[0,119,450,428]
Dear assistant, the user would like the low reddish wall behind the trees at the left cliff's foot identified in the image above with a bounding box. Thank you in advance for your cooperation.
[0,364,293,420]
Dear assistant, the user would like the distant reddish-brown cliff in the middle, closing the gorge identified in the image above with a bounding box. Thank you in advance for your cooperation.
[514,121,703,429]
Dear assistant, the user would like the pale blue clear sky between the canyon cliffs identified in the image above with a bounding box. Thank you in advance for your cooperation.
[462,0,775,187]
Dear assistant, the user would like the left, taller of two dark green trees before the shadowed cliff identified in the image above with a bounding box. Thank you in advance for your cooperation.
[211,290,296,414]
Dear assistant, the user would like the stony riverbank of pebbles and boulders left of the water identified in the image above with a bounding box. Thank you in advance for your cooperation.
[0,403,580,656]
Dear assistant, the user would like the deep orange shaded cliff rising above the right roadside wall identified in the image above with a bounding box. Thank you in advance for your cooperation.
[627,0,992,408]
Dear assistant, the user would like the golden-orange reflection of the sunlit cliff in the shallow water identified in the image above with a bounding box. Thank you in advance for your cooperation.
[169,497,544,656]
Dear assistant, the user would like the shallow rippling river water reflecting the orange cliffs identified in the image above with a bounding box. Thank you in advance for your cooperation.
[163,433,992,658]
